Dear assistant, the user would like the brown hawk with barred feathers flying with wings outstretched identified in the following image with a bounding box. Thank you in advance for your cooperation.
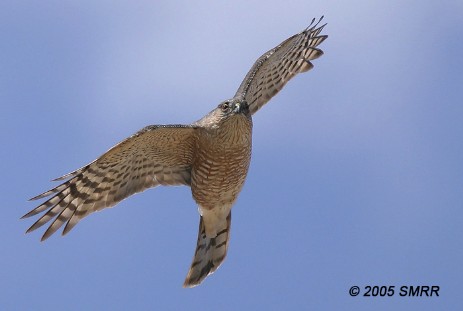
[22,17,327,287]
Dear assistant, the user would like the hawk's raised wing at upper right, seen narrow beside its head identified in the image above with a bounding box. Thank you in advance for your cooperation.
[235,16,328,114]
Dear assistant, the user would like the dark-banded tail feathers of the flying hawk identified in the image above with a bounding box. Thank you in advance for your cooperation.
[183,212,231,287]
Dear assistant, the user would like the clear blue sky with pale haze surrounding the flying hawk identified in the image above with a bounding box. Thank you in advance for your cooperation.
[0,0,463,310]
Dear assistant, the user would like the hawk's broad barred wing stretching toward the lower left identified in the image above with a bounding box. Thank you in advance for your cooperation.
[22,125,195,241]
